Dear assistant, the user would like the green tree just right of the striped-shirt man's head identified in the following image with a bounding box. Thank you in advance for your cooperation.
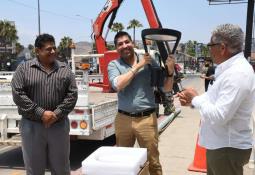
[58,36,73,60]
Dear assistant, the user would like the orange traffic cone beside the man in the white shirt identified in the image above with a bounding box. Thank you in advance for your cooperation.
[188,137,207,173]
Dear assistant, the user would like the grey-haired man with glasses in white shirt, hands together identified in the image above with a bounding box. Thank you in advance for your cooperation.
[178,24,255,175]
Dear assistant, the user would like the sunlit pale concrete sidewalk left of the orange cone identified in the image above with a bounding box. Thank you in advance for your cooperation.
[159,78,255,175]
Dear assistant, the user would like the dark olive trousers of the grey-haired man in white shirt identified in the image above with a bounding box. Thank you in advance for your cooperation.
[206,148,251,175]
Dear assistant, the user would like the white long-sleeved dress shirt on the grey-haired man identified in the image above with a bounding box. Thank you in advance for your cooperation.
[192,53,255,149]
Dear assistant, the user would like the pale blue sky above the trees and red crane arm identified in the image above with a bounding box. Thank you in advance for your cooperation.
[0,0,247,46]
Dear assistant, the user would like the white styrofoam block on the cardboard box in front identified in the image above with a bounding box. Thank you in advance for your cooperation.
[82,146,147,175]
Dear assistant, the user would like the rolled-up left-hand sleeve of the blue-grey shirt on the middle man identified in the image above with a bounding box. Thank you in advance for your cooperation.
[108,61,120,90]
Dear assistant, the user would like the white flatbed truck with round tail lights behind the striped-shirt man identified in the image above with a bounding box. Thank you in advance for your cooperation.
[0,71,117,145]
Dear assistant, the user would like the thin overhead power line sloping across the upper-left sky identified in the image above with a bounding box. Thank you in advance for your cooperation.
[8,0,91,21]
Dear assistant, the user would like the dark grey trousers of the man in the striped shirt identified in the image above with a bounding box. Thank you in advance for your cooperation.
[20,118,70,175]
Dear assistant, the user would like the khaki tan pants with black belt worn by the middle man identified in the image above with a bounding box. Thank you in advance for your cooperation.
[115,113,162,175]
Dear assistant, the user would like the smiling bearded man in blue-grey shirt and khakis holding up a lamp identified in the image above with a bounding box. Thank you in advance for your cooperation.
[108,31,174,175]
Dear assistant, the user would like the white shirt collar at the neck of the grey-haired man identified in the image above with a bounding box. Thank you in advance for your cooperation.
[215,52,244,78]
